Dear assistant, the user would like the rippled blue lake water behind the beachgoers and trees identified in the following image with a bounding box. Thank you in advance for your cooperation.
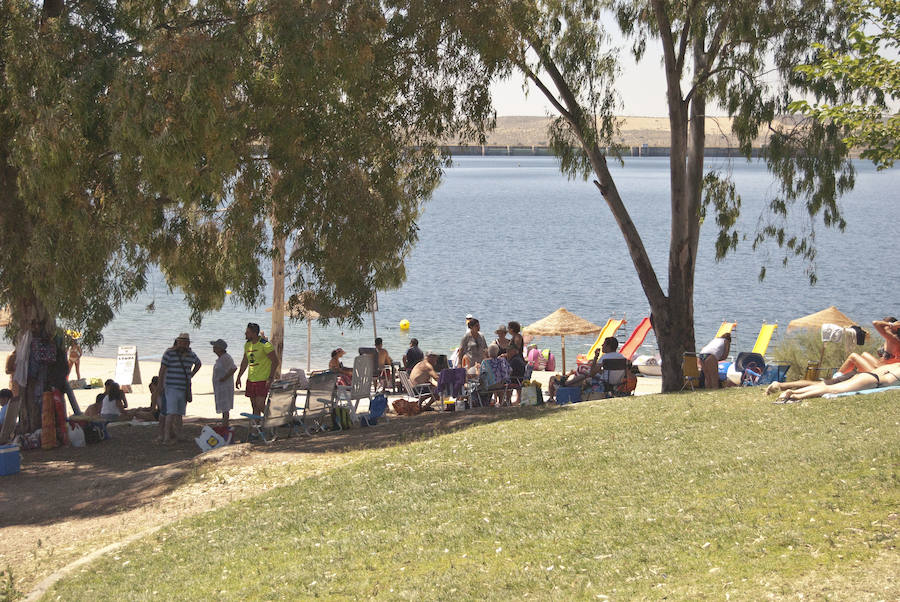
[6,157,900,368]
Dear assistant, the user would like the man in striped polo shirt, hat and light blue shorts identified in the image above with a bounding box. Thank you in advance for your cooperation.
[159,332,203,445]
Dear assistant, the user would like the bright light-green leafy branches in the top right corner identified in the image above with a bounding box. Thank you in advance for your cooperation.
[790,0,900,169]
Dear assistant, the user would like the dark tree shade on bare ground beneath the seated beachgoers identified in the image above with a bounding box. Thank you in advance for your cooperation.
[0,399,576,527]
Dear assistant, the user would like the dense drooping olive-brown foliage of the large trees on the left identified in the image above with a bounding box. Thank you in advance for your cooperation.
[0,0,492,344]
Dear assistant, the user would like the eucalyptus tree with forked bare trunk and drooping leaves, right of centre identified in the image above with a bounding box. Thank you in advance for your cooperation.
[460,0,853,390]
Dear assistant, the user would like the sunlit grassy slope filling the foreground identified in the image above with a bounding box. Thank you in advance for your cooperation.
[48,389,900,600]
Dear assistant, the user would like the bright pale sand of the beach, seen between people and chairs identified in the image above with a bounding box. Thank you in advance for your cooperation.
[0,353,662,419]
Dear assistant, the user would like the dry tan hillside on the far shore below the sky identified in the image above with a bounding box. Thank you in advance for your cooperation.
[464,116,765,147]
